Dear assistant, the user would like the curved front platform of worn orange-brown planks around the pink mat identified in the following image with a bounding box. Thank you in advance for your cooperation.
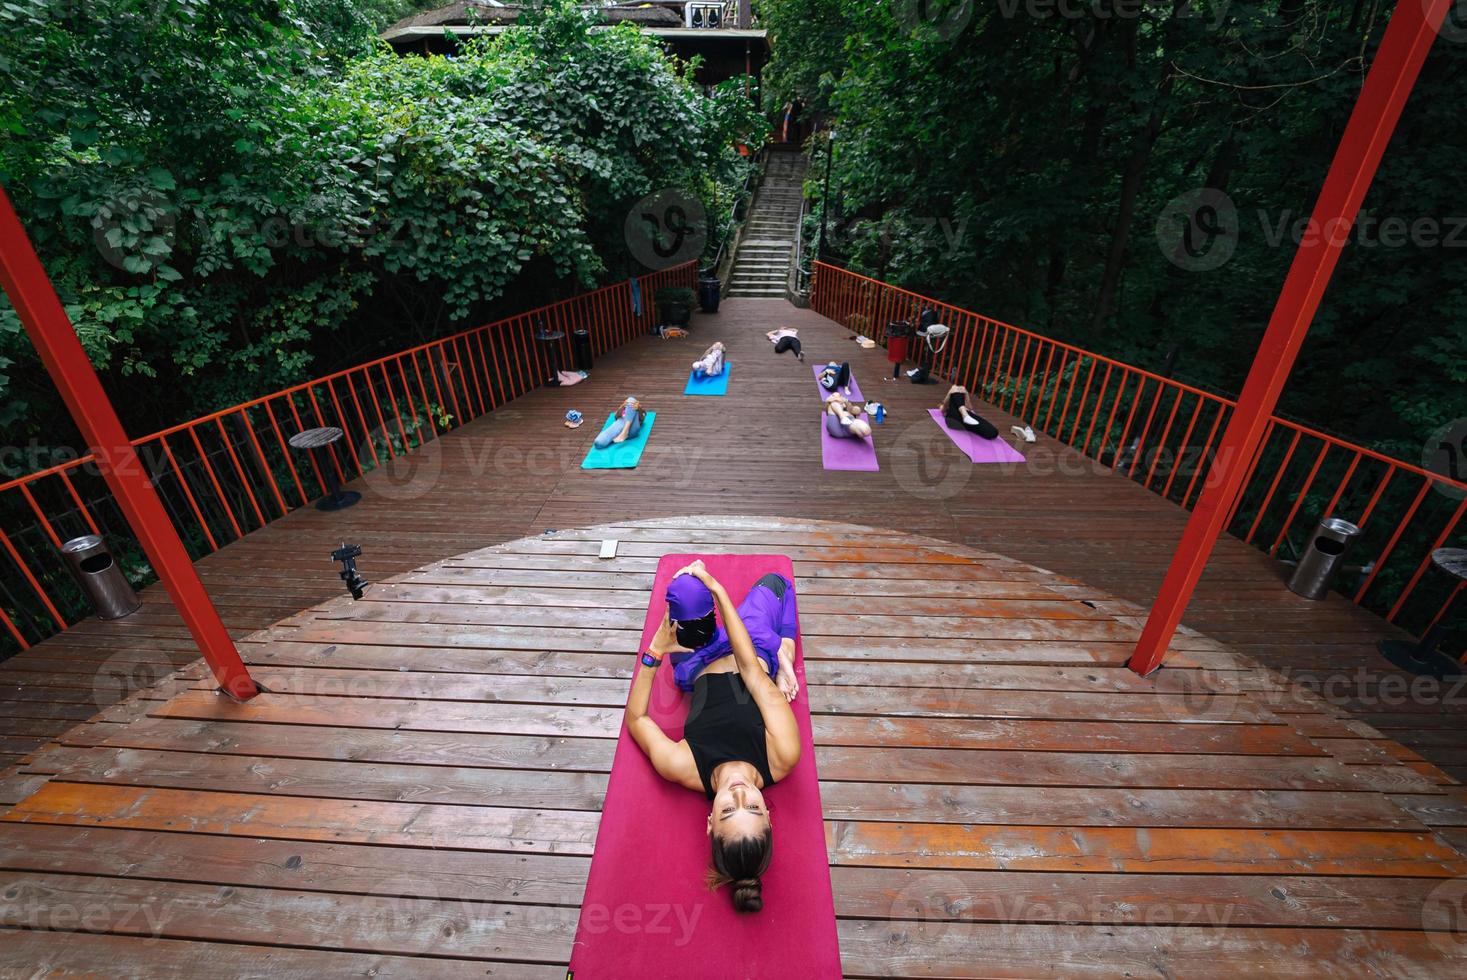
[0,516,1467,979]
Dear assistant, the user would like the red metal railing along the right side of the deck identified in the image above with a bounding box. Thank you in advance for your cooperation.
[810,263,1467,639]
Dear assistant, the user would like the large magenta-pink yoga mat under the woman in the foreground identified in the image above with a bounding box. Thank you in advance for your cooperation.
[569,555,841,980]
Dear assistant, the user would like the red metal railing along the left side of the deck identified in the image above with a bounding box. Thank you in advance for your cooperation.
[0,263,697,650]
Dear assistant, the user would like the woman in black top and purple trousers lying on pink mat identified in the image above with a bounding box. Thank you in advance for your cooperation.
[626,562,800,913]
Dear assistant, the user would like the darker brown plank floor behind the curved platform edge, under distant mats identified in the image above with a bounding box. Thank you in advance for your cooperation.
[0,299,1467,783]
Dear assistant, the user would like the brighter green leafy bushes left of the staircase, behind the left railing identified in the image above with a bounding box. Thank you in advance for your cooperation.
[0,0,761,475]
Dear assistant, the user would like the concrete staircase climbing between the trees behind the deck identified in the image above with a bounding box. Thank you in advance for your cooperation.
[728,150,805,298]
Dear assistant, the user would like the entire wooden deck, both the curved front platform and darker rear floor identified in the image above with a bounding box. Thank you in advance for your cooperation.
[0,301,1467,977]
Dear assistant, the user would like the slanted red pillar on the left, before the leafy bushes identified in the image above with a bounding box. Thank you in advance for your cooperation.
[0,188,260,700]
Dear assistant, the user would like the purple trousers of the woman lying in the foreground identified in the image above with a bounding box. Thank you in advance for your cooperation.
[667,572,800,701]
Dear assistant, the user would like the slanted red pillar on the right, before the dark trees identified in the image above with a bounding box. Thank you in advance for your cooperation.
[1130,0,1452,675]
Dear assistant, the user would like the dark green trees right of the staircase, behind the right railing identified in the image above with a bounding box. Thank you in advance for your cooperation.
[761,0,1467,459]
